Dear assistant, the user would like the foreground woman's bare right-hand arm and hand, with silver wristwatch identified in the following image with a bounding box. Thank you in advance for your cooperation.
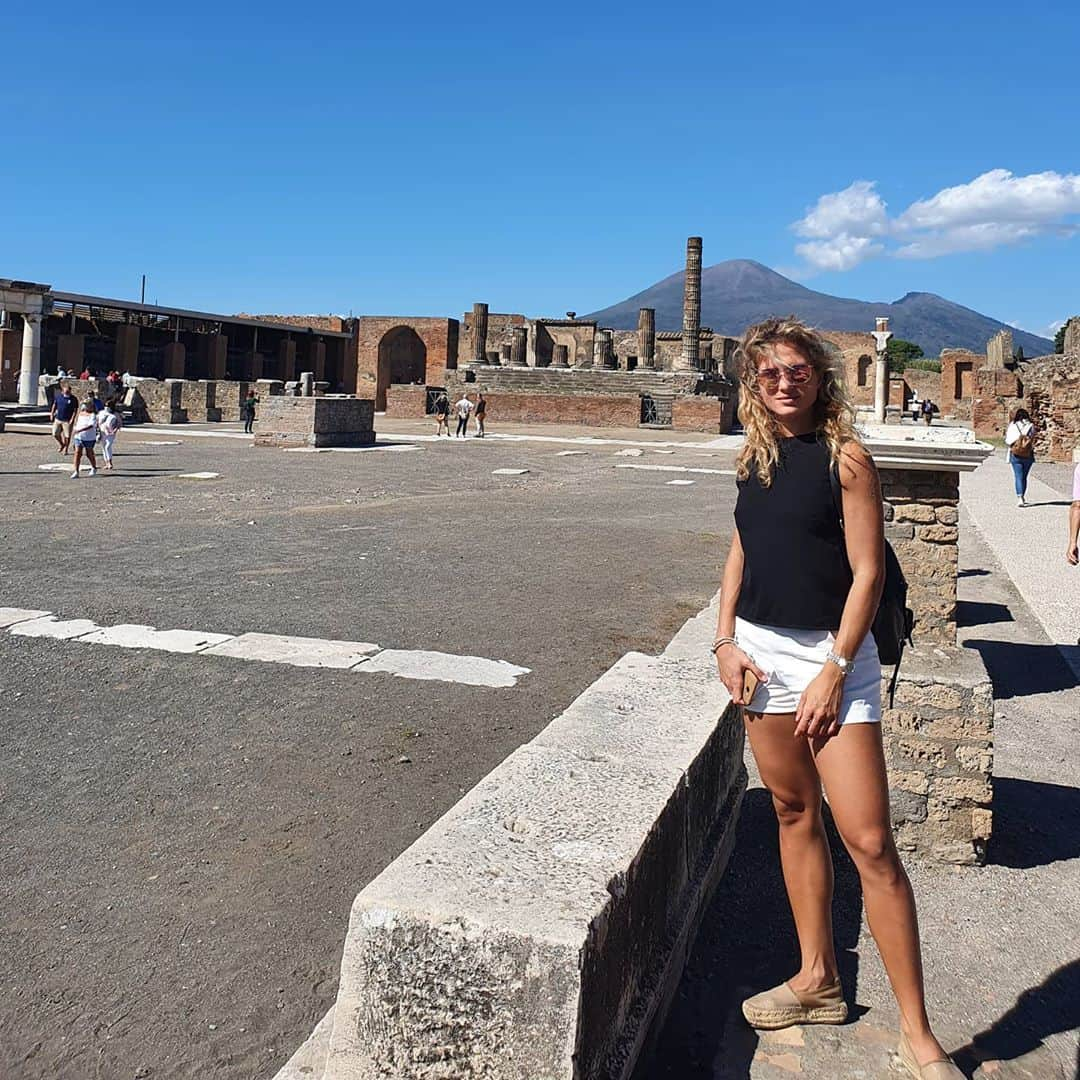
[795,442,885,739]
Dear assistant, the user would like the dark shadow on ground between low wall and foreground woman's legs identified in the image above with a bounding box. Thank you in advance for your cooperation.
[634,788,865,1080]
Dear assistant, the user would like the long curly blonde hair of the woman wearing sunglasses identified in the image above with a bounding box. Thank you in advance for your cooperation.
[735,315,859,487]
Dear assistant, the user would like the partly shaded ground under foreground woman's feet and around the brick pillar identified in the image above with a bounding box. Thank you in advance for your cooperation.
[638,467,1080,1080]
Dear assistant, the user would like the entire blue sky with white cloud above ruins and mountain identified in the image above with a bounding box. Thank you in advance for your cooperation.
[0,0,1080,333]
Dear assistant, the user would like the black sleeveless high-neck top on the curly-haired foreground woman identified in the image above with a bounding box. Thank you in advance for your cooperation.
[735,432,852,631]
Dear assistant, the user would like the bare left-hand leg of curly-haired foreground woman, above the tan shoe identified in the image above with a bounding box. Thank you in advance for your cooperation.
[746,713,837,993]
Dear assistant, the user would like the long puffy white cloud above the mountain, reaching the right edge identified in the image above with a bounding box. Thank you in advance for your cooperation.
[792,168,1080,270]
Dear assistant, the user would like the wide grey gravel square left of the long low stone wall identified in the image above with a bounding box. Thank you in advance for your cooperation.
[0,428,733,1080]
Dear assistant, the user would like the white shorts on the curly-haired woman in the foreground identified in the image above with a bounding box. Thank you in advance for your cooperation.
[734,619,881,725]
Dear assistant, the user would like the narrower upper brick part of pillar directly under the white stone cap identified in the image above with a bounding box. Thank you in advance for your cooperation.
[881,469,960,645]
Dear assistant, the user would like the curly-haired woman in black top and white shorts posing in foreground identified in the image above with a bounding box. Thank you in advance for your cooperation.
[713,319,962,1080]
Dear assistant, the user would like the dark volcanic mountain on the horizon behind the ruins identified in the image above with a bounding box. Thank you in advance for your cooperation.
[588,259,1054,356]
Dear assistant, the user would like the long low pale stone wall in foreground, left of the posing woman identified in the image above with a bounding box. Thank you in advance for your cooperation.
[280,608,746,1080]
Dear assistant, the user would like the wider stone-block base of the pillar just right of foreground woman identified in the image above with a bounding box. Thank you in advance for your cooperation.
[882,646,994,864]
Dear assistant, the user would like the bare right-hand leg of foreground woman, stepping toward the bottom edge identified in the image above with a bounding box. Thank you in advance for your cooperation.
[813,724,944,1064]
